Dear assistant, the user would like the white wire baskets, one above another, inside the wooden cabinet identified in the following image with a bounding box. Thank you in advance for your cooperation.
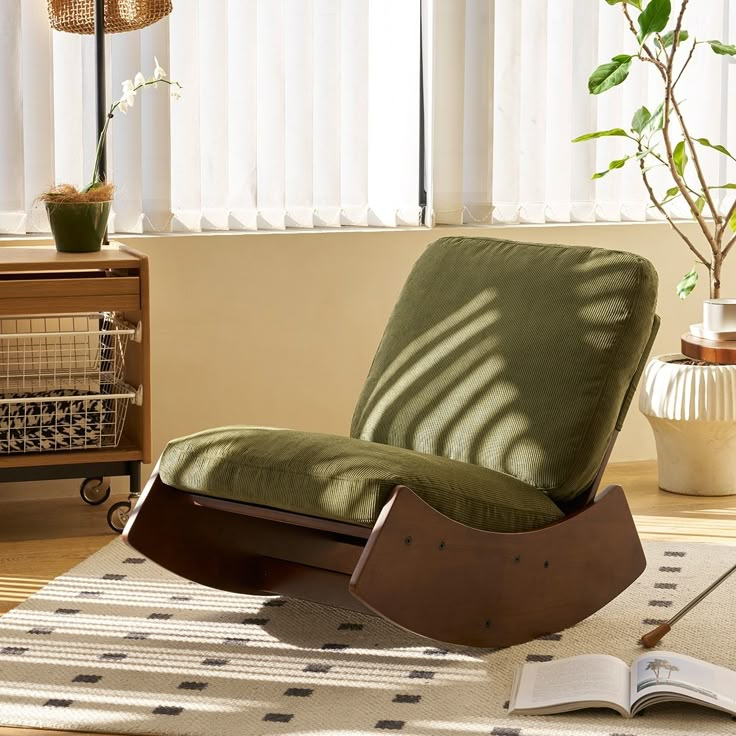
[0,312,137,455]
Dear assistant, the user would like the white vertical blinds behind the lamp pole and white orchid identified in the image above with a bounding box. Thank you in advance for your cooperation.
[0,0,420,233]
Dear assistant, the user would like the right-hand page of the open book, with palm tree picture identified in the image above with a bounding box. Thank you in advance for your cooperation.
[630,652,736,712]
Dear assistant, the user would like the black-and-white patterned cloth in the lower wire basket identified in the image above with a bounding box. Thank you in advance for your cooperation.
[0,389,110,454]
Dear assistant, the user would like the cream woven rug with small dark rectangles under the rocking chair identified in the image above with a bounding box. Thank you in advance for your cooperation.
[0,540,736,736]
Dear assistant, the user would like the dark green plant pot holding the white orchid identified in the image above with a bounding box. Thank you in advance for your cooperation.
[46,202,112,253]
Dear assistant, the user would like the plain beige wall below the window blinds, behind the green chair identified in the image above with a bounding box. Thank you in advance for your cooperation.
[2,224,733,498]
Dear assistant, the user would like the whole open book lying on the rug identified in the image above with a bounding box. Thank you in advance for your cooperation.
[509,651,736,718]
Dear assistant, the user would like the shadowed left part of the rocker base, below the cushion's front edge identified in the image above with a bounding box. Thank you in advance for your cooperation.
[123,472,374,611]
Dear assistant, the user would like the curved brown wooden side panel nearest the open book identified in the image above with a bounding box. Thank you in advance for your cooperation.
[350,486,646,647]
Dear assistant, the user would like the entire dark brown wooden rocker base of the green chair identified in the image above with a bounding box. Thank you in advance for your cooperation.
[123,472,646,647]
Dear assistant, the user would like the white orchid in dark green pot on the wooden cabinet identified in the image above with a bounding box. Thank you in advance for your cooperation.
[38,57,181,253]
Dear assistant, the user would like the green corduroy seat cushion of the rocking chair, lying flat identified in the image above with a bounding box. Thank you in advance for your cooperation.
[159,427,563,532]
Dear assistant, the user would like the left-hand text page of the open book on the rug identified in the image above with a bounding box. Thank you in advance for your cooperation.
[509,654,630,713]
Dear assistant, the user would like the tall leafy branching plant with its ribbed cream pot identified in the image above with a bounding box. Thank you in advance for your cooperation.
[574,0,736,495]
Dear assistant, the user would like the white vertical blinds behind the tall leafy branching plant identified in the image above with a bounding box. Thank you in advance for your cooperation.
[425,0,736,224]
